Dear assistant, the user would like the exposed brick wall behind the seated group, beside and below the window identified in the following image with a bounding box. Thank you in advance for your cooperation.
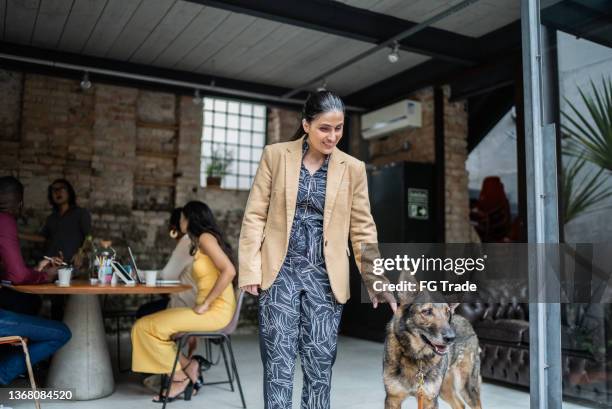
[0,70,252,326]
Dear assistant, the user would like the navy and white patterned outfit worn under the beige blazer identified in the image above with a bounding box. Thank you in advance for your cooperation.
[259,139,342,409]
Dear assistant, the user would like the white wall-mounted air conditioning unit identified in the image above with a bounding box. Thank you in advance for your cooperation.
[361,99,422,139]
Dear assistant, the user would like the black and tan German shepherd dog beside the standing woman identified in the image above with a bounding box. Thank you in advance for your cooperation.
[383,303,481,409]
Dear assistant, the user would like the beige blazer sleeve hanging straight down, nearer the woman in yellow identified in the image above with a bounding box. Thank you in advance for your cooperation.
[238,146,272,287]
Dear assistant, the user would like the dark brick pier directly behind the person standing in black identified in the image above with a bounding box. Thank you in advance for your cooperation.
[19,74,94,211]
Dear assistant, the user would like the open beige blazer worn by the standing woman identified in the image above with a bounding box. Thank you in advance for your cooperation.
[238,137,380,303]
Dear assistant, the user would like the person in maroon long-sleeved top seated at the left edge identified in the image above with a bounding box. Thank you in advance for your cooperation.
[0,176,57,315]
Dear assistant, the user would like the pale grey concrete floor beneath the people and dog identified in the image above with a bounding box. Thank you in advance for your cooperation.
[0,335,586,409]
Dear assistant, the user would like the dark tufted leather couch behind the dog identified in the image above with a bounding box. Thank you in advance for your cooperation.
[457,298,612,407]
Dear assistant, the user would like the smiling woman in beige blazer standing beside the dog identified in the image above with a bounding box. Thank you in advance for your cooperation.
[238,91,396,409]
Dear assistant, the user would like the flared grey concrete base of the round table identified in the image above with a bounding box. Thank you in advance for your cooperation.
[47,294,115,400]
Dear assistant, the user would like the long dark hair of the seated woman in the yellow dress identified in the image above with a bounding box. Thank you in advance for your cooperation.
[182,200,234,264]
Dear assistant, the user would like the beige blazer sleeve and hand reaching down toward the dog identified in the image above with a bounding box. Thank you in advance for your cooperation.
[349,161,388,299]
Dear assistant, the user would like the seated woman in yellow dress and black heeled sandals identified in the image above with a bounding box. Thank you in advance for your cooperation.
[132,201,236,402]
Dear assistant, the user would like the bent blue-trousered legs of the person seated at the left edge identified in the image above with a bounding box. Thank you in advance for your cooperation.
[0,310,71,385]
